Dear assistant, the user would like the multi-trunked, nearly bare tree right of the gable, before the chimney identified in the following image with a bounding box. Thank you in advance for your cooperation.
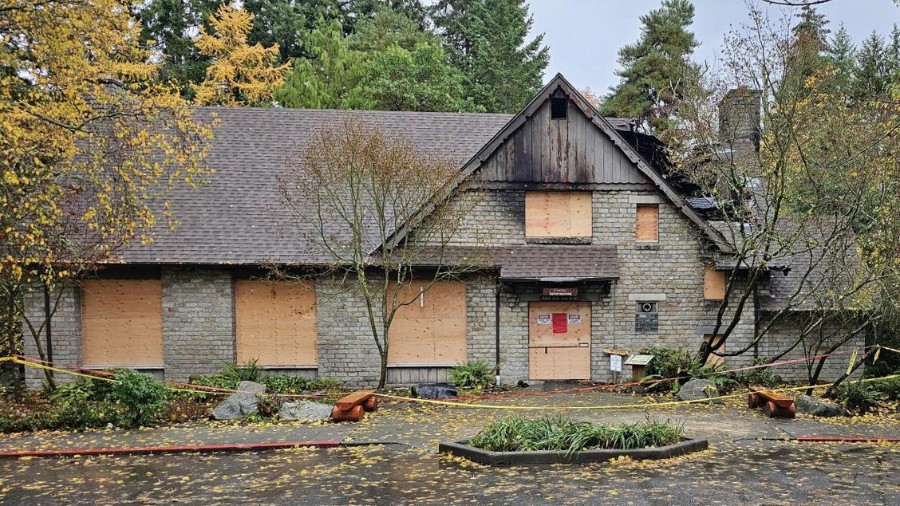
[670,3,900,382]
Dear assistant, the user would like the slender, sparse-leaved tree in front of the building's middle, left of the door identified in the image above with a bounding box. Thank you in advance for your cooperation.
[279,117,485,388]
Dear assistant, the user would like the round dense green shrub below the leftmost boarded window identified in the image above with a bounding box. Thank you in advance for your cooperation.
[108,370,169,427]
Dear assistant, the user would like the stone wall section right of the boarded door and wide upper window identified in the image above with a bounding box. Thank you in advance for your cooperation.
[592,191,753,381]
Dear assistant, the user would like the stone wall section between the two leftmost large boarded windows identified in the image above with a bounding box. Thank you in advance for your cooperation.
[162,268,235,381]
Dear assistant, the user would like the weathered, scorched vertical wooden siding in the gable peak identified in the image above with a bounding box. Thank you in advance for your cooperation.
[481,100,648,184]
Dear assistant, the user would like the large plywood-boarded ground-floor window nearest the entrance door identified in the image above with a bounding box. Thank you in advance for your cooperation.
[388,281,466,366]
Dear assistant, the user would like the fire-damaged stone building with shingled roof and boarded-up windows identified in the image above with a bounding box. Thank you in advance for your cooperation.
[25,75,861,386]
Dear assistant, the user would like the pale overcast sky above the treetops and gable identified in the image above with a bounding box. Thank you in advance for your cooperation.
[529,0,900,95]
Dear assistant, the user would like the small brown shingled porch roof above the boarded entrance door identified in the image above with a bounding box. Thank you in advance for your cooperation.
[498,245,619,283]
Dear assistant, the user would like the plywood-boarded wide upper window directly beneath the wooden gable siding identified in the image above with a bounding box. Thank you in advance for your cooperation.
[525,191,592,238]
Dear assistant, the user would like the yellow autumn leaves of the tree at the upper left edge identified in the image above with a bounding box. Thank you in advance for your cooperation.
[0,0,211,286]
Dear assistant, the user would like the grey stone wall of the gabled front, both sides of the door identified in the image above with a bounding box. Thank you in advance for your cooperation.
[426,190,754,383]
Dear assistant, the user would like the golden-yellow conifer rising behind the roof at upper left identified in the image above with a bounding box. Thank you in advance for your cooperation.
[196,4,291,105]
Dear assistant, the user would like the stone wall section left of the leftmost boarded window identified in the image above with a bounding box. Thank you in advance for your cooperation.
[22,286,81,388]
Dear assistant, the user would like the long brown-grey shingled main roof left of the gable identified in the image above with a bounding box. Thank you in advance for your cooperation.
[120,107,512,265]
